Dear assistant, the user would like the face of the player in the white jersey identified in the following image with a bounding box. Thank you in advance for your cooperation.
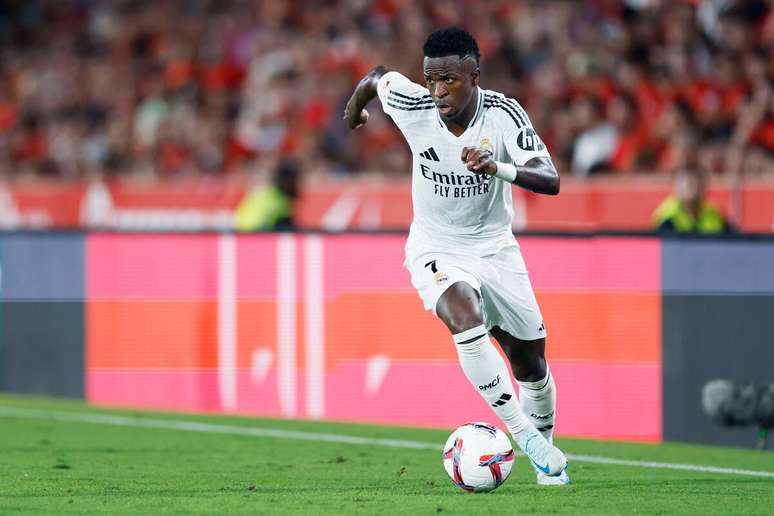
[424,56,479,121]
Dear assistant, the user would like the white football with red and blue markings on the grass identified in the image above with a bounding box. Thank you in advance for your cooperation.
[443,423,514,492]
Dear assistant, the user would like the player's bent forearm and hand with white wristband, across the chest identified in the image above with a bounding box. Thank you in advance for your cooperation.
[462,147,559,199]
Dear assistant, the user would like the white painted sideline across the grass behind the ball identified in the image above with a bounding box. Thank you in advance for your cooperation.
[0,407,774,478]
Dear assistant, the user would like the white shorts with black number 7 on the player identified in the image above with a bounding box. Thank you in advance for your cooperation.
[406,246,546,340]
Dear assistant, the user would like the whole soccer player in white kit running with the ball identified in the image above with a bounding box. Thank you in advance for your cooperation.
[344,27,569,484]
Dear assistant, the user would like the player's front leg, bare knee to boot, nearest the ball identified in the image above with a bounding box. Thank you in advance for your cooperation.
[435,281,567,475]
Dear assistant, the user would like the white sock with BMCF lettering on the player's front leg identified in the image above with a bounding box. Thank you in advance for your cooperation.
[453,324,534,439]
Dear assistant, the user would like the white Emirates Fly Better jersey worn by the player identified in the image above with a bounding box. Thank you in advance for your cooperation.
[377,72,549,258]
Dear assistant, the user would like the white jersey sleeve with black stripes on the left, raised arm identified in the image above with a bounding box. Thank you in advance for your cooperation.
[377,72,435,127]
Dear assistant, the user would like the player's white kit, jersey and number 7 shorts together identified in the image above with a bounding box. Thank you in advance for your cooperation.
[378,72,549,340]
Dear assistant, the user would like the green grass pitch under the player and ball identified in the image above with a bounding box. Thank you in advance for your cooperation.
[0,396,774,515]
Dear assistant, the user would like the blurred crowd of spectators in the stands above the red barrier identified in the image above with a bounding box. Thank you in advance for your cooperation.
[0,0,774,179]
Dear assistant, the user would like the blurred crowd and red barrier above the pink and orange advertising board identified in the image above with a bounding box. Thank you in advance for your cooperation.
[0,0,774,232]
